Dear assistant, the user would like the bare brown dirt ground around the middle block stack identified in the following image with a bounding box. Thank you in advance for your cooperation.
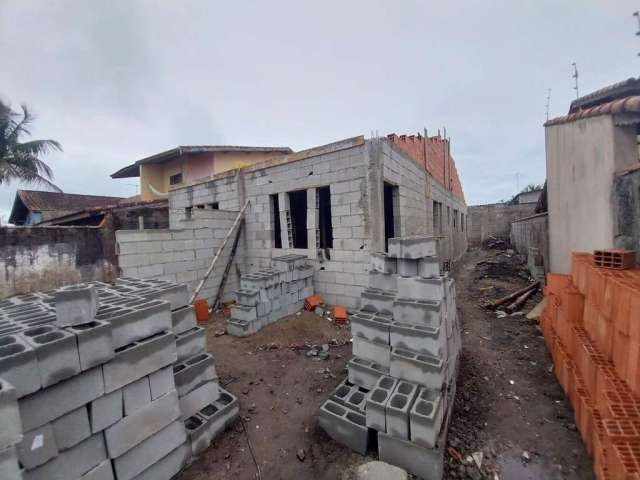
[180,250,595,480]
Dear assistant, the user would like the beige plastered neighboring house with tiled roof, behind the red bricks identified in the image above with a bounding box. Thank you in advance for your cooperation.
[545,79,640,273]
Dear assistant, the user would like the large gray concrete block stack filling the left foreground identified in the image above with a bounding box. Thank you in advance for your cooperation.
[0,278,238,480]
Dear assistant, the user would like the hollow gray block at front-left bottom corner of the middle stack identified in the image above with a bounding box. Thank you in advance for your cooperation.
[318,400,369,455]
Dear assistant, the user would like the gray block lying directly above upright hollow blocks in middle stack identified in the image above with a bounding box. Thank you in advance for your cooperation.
[389,348,446,390]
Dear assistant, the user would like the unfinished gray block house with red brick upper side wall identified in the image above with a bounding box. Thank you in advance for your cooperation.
[117,134,467,308]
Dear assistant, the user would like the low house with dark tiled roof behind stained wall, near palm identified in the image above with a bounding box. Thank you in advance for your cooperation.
[9,190,123,225]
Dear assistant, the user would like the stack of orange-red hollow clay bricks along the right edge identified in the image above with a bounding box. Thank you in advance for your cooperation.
[541,253,640,480]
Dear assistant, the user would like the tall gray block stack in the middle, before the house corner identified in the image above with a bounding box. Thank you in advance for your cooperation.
[318,235,461,480]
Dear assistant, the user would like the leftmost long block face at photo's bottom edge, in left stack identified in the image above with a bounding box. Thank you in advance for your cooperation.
[23,433,107,480]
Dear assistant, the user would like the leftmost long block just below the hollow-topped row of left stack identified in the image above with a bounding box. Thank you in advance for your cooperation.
[18,367,104,431]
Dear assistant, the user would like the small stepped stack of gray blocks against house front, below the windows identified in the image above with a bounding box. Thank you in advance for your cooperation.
[227,255,313,337]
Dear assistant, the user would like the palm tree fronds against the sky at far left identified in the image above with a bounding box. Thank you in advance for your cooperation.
[0,100,62,192]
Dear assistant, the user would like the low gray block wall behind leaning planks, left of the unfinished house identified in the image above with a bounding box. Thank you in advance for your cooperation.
[116,208,244,301]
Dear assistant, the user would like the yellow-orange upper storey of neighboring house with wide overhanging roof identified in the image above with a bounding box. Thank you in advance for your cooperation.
[111,145,292,201]
